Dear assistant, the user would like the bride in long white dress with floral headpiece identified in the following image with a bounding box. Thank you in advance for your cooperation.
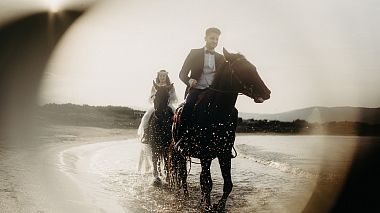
[137,70,178,171]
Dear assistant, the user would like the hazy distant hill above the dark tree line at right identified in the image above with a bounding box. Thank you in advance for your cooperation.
[239,107,380,124]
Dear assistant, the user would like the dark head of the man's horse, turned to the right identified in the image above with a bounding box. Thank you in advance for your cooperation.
[223,48,271,103]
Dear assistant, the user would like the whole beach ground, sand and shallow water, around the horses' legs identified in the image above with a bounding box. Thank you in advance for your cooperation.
[0,126,372,212]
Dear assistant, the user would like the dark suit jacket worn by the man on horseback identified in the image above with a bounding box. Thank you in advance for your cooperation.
[179,47,225,97]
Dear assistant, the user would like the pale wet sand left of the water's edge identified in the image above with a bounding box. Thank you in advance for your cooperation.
[0,126,137,212]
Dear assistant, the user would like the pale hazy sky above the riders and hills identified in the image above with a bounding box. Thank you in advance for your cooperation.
[0,0,380,113]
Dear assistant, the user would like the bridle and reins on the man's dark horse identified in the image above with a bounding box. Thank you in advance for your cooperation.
[207,56,253,97]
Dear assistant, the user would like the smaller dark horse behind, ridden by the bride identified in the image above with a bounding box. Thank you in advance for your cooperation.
[148,81,173,184]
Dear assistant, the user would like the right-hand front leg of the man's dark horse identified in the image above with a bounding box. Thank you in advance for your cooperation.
[214,156,233,212]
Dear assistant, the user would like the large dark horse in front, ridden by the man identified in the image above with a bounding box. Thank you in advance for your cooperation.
[170,49,271,212]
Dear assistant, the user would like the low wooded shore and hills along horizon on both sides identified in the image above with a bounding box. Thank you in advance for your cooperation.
[36,103,380,136]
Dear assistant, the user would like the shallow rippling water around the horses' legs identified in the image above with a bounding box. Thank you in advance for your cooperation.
[61,136,374,212]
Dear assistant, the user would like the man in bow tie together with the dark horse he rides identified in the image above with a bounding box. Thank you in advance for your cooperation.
[175,28,271,212]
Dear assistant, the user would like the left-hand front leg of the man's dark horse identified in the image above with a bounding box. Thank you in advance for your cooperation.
[200,159,212,211]
